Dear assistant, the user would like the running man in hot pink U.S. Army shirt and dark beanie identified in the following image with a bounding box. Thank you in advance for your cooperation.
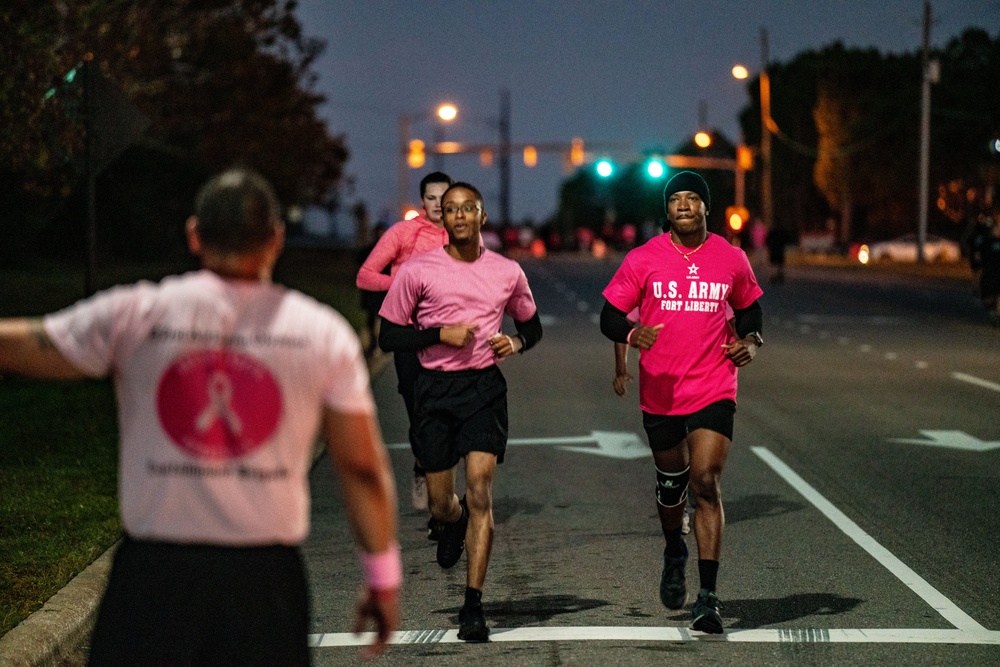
[601,171,763,633]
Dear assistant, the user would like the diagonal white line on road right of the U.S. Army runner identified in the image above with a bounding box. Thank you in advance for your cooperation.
[752,447,986,632]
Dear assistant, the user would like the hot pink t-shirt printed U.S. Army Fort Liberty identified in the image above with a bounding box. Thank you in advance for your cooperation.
[604,233,763,415]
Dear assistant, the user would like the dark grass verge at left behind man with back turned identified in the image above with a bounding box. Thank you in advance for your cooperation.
[0,249,364,636]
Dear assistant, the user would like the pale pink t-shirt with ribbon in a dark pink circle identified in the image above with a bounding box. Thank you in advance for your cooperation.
[44,271,375,546]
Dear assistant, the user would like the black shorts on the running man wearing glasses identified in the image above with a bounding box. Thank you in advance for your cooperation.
[413,365,507,472]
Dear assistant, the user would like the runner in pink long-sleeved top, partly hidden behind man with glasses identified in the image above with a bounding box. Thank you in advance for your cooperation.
[355,171,452,512]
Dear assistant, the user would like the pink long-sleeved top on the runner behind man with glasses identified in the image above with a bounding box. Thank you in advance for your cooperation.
[355,215,448,292]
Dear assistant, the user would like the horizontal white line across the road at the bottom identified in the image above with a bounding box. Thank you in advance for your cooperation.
[309,626,1000,648]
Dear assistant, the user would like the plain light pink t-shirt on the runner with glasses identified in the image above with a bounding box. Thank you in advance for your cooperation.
[379,248,536,371]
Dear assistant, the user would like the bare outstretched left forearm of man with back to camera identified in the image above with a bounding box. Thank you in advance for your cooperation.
[0,318,86,380]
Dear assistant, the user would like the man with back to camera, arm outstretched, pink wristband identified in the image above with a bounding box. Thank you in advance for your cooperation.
[0,169,402,666]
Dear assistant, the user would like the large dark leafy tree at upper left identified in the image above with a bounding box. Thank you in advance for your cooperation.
[0,0,348,264]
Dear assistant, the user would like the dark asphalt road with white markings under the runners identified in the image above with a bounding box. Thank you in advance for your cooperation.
[305,253,1000,665]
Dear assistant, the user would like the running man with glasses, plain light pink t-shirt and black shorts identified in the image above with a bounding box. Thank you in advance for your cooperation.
[379,183,542,641]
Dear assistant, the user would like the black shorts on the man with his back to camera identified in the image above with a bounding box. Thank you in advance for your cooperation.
[89,537,309,666]
